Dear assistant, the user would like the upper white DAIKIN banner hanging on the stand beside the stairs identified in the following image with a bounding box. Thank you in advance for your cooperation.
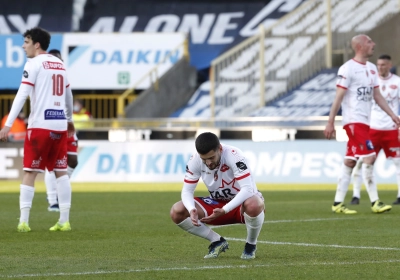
[62,33,185,89]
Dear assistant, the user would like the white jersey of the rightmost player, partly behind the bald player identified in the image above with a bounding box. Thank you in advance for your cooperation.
[370,73,400,130]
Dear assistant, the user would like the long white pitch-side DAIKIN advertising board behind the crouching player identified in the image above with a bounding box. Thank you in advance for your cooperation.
[72,140,396,184]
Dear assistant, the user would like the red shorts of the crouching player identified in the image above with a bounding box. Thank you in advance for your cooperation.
[194,197,244,225]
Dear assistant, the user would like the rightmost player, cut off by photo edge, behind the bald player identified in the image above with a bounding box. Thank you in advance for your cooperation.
[350,54,400,205]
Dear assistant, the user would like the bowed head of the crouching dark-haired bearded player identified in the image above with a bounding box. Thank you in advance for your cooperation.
[195,132,222,170]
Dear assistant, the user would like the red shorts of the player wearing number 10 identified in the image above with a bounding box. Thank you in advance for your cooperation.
[23,128,67,172]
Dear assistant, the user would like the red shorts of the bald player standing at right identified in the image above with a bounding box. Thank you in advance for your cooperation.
[343,123,375,160]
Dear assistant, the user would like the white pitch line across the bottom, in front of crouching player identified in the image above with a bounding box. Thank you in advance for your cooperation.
[0,260,400,278]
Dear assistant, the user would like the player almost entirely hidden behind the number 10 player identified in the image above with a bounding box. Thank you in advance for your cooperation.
[44,49,78,212]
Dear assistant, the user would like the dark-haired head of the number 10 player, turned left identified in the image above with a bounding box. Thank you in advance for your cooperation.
[22,27,51,58]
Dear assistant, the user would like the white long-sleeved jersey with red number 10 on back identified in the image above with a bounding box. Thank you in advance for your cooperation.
[6,53,72,131]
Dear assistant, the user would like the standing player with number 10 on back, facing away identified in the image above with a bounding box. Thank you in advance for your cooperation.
[0,27,75,232]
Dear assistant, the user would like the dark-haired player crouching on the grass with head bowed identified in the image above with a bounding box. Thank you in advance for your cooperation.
[170,132,264,259]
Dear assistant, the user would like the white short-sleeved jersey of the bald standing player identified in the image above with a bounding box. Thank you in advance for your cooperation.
[336,59,379,126]
